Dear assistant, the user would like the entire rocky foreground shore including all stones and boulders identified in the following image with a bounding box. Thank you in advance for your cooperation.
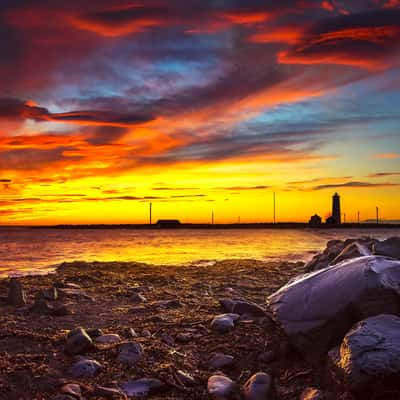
[0,238,400,400]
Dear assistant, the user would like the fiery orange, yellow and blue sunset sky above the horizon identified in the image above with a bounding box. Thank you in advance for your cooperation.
[0,0,400,225]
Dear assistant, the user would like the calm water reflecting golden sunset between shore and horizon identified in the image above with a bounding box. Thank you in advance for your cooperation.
[0,228,400,276]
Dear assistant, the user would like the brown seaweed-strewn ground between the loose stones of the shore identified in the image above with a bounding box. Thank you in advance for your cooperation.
[0,260,328,400]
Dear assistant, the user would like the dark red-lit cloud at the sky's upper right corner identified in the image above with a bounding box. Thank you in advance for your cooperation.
[278,9,400,70]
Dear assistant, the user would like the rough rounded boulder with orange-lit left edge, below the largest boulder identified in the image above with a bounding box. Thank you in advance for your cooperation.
[336,314,400,390]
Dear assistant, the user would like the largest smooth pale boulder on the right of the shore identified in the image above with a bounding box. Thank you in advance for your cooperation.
[269,256,400,360]
